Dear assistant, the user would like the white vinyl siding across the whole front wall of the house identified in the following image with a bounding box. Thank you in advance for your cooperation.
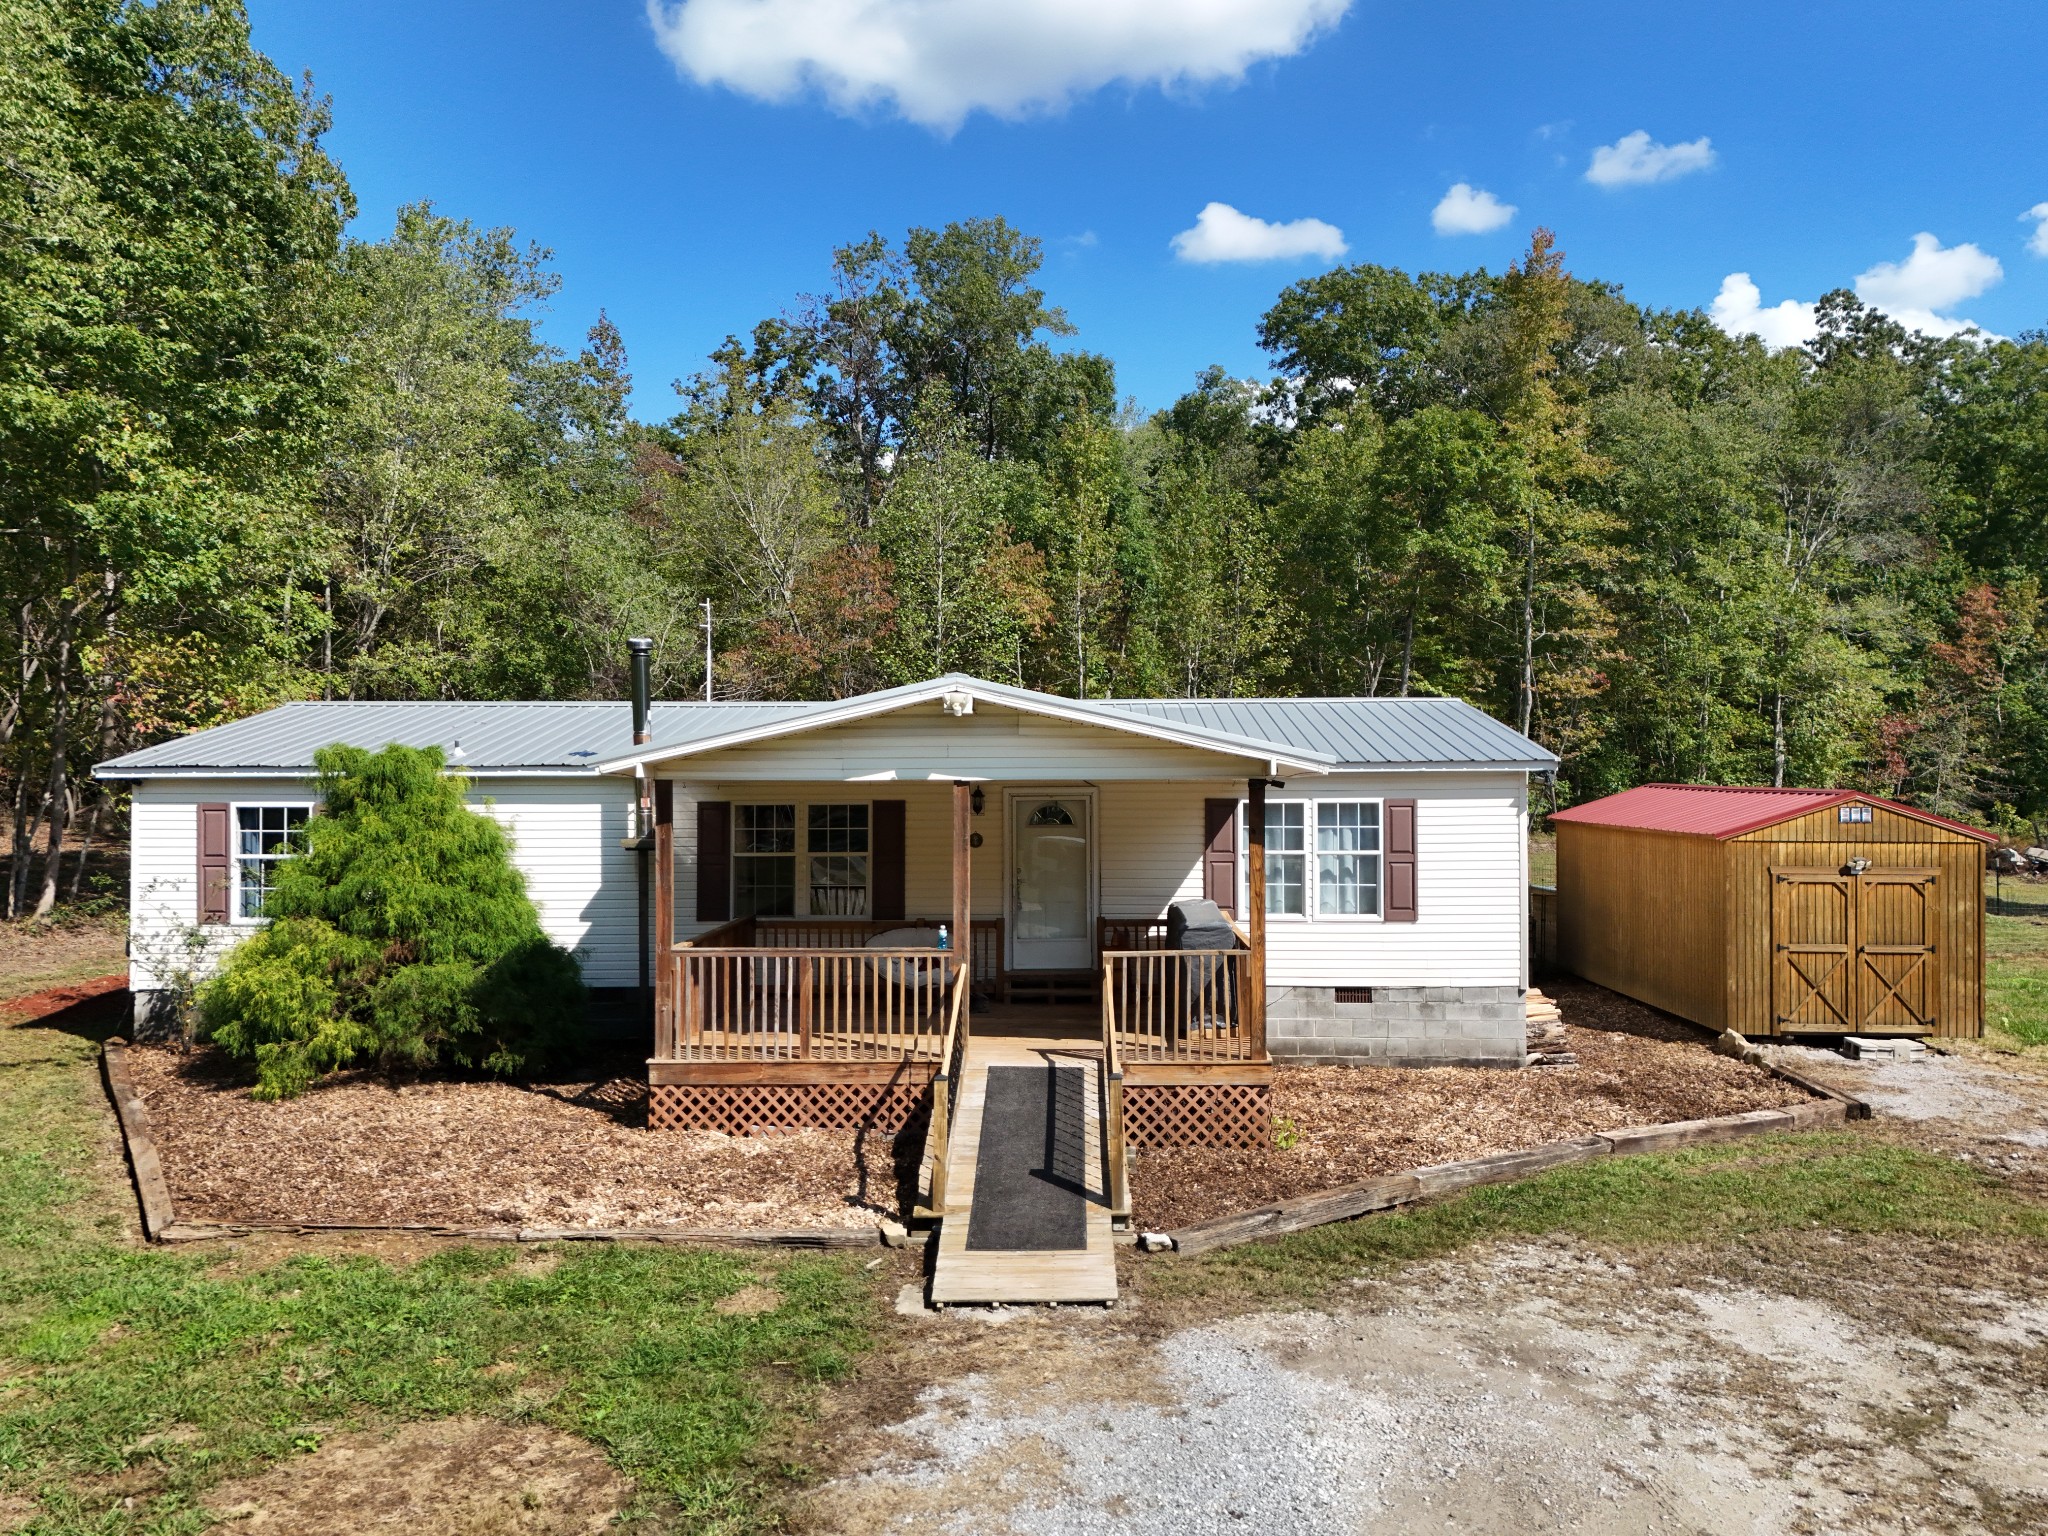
[112,765,1526,1003]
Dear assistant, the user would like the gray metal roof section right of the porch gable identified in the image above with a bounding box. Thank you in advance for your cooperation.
[1110,698,1556,772]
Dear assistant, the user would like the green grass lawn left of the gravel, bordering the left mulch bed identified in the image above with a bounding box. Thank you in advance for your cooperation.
[0,1003,877,1536]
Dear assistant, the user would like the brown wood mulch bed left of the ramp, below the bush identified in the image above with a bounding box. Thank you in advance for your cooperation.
[129,1047,924,1231]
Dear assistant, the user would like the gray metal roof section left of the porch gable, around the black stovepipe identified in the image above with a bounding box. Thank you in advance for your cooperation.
[94,700,815,778]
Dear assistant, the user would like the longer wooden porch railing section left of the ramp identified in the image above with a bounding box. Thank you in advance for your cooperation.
[671,942,961,1061]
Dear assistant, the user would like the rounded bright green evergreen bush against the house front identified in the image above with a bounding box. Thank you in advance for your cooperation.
[199,745,584,1098]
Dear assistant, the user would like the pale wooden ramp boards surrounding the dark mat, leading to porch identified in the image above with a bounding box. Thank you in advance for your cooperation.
[932,1028,1116,1307]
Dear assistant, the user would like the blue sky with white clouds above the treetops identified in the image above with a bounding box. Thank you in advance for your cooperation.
[250,0,2048,420]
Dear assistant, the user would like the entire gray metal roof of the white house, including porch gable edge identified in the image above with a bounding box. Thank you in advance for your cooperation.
[94,678,1556,778]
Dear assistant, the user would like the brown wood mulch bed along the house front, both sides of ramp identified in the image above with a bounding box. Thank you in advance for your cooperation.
[129,981,1808,1253]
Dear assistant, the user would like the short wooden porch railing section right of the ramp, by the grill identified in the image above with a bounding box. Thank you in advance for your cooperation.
[1102,948,1266,1065]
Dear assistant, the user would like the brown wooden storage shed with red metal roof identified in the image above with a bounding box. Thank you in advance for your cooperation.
[1552,784,1995,1036]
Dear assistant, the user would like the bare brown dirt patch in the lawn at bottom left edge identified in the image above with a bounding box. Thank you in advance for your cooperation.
[207,1419,633,1536]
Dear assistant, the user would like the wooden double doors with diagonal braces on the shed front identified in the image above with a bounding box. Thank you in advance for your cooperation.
[1772,864,1939,1034]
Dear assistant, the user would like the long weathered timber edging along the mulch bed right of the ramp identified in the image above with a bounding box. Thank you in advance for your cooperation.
[1165,1094,1870,1253]
